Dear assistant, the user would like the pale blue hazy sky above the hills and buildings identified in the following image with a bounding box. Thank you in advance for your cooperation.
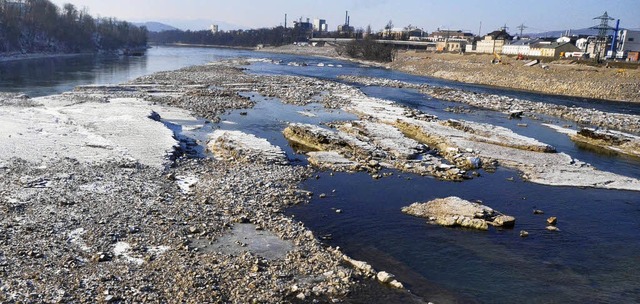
[52,0,640,35]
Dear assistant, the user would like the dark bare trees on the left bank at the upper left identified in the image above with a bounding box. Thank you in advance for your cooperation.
[0,0,148,53]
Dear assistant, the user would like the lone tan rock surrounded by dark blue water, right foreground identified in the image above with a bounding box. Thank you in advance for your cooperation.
[402,196,515,230]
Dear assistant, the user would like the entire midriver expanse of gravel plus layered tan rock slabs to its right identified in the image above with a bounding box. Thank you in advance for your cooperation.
[0,56,640,303]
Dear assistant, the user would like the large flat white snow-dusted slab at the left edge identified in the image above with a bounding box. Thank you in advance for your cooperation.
[0,95,189,168]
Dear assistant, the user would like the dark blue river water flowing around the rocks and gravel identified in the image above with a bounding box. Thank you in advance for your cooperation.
[0,47,640,303]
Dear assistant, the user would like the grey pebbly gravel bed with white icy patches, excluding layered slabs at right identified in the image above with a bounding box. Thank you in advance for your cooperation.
[0,61,418,303]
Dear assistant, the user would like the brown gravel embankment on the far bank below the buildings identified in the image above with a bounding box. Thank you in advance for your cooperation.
[263,46,640,102]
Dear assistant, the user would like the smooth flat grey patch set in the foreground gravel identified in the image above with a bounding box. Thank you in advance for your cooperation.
[191,224,295,260]
